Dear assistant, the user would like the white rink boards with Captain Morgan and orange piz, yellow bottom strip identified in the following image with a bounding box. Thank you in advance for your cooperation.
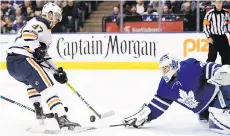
[1,33,226,70]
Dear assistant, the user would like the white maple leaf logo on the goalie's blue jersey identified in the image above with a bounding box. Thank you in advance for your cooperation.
[177,89,199,109]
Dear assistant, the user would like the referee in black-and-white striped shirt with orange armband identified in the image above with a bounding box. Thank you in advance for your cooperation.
[203,0,230,65]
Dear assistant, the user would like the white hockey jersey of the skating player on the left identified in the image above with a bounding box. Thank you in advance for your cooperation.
[7,16,52,58]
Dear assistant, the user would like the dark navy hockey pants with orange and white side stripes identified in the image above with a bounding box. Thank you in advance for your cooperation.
[6,54,53,93]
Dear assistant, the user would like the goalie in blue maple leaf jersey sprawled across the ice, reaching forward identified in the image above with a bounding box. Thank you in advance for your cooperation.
[123,54,230,134]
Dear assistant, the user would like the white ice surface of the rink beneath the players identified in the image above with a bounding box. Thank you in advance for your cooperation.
[0,70,226,136]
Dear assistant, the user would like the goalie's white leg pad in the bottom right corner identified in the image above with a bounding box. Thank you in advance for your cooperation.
[209,107,230,135]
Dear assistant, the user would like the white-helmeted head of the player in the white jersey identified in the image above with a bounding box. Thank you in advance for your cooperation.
[42,2,62,27]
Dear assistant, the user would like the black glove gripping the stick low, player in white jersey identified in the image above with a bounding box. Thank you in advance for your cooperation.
[53,67,68,84]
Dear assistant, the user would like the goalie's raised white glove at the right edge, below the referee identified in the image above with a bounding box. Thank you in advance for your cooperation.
[208,65,230,86]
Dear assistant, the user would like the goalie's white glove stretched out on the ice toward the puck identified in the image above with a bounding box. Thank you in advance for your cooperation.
[123,104,151,128]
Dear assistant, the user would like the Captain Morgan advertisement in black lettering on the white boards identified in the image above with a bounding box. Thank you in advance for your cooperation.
[52,34,157,61]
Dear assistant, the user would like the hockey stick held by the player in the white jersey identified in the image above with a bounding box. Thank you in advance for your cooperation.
[43,59,115,119]
